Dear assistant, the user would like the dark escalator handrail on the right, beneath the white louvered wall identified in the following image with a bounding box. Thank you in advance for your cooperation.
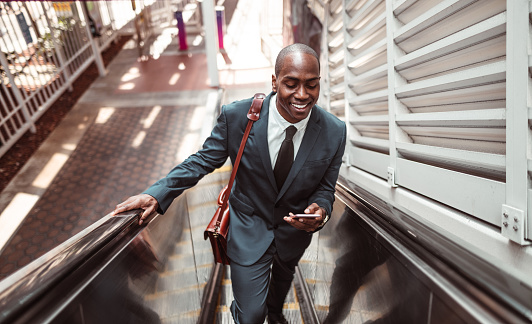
[340,181,532,323]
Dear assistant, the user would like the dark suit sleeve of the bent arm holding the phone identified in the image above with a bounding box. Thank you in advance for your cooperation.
[308,124,346,219]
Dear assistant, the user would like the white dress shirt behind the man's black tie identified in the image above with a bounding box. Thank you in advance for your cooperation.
[268,94,312,169]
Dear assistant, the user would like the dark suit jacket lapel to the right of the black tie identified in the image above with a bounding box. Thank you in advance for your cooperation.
[276,107,321,197]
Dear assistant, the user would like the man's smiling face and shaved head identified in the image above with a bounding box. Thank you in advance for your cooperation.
[272,52,320,124]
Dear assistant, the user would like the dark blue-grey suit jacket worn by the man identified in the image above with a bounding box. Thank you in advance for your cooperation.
[145,94,346,265]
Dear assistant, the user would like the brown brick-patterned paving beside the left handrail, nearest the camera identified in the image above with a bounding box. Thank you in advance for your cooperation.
[0,106,194,277]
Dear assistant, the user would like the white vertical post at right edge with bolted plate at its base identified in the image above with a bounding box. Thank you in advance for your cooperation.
[501,0,530,244]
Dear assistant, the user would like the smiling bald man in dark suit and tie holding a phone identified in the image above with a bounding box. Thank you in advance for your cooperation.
[113,44,346,324]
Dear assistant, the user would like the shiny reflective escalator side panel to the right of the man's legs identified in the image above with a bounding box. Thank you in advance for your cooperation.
[298,188,527,323]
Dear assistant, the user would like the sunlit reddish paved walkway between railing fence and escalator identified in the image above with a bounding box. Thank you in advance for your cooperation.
[0,0,273,280]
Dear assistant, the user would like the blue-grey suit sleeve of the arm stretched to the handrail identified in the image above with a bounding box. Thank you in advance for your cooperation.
[143,106,228,214]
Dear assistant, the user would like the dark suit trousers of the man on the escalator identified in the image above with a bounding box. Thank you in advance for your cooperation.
[230,241,302,324]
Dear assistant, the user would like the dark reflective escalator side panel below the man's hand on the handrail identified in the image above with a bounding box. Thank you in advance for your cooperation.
[51,196,193,324]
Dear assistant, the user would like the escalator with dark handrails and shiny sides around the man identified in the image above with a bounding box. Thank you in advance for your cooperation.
[0,169,532,324]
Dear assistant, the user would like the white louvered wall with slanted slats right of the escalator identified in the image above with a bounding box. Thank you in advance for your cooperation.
[316,0,532,296]
